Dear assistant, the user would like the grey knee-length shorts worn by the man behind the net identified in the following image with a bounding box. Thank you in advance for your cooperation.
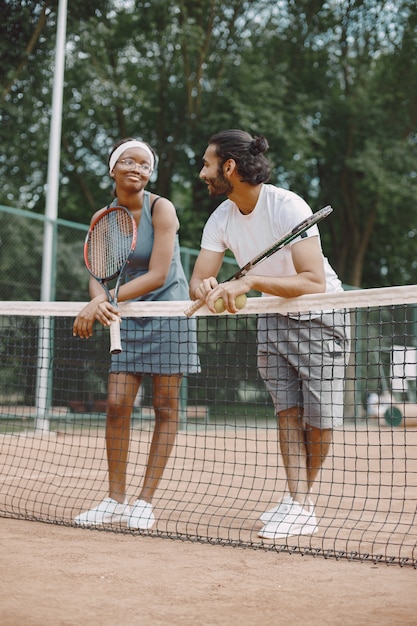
[258,311,350,429]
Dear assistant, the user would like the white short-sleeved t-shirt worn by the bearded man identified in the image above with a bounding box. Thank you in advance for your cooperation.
[201,184,343,292]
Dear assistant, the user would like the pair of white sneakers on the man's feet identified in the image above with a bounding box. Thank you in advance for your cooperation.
[258,499,318,539]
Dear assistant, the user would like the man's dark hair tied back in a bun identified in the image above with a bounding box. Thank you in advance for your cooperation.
[209,129,271,185]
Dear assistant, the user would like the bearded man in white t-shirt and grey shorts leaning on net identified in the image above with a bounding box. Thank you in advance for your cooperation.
[190,130,349,539]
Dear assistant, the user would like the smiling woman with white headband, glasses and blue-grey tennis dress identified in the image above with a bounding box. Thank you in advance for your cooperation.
[73,139,199,530]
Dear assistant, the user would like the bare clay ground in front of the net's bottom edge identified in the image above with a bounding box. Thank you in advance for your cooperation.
[0,518,417,626]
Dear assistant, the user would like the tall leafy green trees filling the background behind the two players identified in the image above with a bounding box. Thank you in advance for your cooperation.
[0,0,417,287]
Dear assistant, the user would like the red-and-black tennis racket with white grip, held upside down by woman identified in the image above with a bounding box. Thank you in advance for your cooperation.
[84,206,137,354]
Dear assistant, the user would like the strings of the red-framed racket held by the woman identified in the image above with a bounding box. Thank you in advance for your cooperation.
[87,210,134,279]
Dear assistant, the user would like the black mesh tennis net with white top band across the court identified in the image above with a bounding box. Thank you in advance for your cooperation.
[0,285,417,567]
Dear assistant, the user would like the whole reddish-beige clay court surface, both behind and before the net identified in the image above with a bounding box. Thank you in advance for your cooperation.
[0,428,417,626]
